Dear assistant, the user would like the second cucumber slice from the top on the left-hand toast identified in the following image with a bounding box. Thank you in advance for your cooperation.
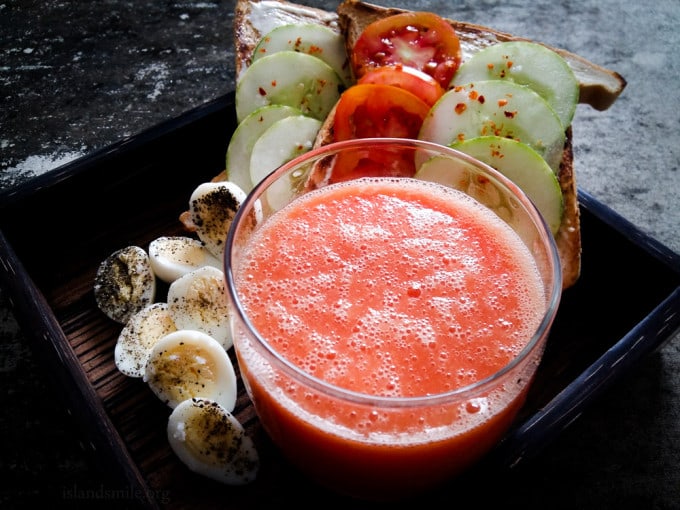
[235,51,344,122]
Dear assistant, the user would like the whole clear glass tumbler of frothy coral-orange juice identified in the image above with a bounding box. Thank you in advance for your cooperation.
[225,138,561,500]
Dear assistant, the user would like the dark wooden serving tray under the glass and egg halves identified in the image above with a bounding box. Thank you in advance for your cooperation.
[0,93,680,509]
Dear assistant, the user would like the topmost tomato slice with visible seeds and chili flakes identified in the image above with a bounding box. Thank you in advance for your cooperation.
[351,12,462,89]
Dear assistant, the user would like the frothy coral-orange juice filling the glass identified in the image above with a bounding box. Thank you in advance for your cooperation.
[235,178,546,494]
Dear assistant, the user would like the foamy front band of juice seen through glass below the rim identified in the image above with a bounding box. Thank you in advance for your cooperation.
[239,332,538,444]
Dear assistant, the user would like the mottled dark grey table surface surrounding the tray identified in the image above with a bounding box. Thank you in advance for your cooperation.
[0,0,680,509]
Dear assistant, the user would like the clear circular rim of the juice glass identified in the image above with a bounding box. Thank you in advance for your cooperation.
[223,138,562,408]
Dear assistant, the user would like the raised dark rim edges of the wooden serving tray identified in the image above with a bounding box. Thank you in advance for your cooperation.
[0,91,680,509]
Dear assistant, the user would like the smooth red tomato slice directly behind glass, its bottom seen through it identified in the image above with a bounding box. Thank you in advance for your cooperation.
[329,83,430,182]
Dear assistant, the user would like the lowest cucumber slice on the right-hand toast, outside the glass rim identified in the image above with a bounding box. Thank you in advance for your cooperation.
[451,136,564,235]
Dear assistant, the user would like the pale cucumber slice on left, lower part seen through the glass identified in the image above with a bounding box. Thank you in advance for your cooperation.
[250,115,321,209]
